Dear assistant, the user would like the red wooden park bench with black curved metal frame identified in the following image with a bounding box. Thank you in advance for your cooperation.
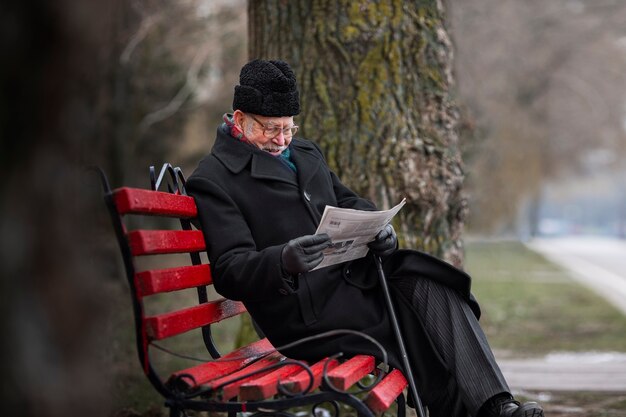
[103,166,407,416]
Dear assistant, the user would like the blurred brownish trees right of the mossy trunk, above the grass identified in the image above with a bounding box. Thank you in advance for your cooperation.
[450,0,626,238]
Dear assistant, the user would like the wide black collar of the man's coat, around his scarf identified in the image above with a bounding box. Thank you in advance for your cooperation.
[211,127,322,187]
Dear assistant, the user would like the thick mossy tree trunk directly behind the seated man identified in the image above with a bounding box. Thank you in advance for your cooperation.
[248,0,467,266]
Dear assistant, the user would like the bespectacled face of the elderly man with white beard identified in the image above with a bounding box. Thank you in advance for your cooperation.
[239,113,297,156]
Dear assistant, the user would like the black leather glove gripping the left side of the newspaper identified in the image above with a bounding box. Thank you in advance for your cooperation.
[281,233,332,275]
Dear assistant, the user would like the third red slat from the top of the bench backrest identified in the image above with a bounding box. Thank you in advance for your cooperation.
[135,264,213,297]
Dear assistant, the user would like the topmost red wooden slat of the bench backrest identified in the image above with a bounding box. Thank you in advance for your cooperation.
[113,187,198,219]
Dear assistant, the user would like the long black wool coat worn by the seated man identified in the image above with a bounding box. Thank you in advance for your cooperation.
[186,127,480,374]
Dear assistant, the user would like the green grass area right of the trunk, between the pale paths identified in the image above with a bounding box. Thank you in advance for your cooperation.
[466,242,626,357]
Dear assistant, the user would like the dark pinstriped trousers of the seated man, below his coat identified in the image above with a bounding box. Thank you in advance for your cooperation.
[389,277,510,417]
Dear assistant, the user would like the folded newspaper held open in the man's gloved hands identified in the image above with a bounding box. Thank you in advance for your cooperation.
[313,199,406,270]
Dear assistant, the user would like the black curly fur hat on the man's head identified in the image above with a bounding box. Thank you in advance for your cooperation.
[233,59,300,117]
